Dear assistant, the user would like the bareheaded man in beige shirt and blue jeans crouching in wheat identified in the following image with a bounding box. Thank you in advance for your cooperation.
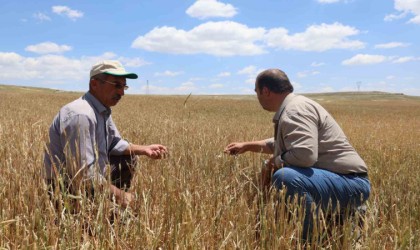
[225,69,370,239]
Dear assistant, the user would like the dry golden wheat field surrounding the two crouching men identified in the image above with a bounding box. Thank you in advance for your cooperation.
[0,87,420,249]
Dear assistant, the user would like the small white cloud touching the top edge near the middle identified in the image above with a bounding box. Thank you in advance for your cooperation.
[186,0,237,19]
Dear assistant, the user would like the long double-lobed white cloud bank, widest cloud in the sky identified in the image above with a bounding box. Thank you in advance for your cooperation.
[131,21,365,56]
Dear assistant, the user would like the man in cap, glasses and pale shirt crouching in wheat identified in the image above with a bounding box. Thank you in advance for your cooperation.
[44,60,168,207]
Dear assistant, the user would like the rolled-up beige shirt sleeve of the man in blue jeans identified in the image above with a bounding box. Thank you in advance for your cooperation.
[281,111,318,167]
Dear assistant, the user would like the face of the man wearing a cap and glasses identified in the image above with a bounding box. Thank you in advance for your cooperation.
[91,75,126,108]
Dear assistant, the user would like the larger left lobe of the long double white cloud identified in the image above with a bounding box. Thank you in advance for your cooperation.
[132,21,265,56]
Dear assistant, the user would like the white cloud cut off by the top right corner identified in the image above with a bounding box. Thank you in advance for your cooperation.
[384,0,420,24]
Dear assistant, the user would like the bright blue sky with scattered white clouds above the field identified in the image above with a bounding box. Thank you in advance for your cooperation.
[0,0,420,96]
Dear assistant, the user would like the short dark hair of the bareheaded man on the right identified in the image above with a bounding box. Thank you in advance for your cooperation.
[256,69,293,94]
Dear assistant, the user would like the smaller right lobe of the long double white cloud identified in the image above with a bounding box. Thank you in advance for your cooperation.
[266,23,365,52]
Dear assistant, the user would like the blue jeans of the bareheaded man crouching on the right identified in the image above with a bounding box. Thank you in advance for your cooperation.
[272,166,370,239]
